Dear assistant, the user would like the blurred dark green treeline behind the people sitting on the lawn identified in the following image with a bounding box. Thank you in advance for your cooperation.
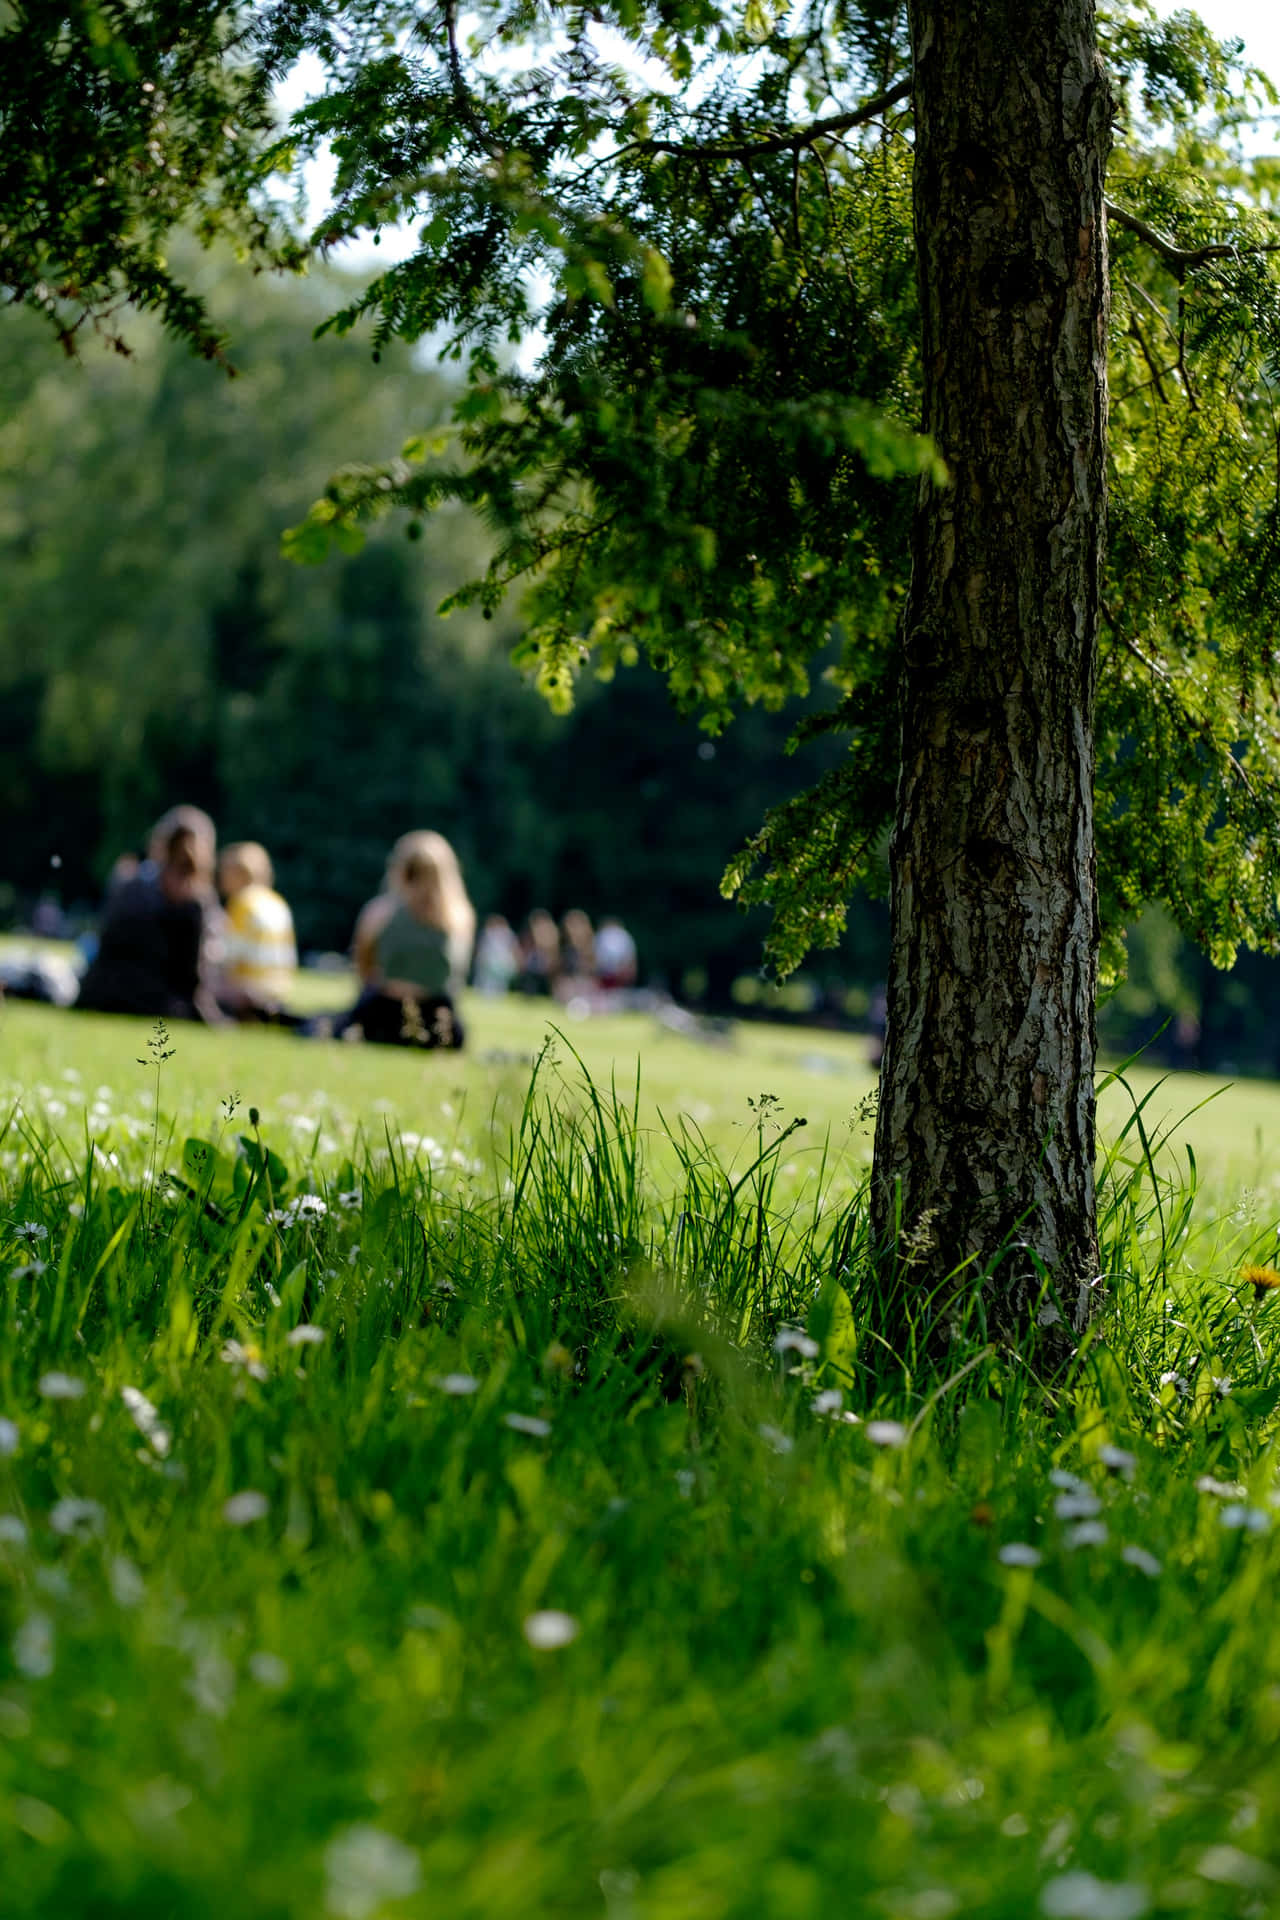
[0,263,885,1002]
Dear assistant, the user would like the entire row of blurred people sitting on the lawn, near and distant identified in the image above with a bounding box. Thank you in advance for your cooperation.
[36,806,637,1046]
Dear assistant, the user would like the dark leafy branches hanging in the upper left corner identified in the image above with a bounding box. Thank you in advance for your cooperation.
[0,0,301,359]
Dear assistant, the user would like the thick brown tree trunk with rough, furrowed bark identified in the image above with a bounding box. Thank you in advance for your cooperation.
[873,0,1111,1346]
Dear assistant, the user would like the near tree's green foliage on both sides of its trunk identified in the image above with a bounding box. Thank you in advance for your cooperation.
[268,0,1280,975]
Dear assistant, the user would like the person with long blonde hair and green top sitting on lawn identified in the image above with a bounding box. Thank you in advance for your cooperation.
[334,831,476,1046]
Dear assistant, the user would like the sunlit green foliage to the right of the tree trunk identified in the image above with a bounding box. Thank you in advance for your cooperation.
[1100,189,1280,966]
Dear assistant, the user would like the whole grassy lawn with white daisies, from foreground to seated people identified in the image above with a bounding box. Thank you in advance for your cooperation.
[0,1004,1280,1920]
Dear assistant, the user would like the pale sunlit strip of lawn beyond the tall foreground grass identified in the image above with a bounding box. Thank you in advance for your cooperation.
[0,935,1280,1182]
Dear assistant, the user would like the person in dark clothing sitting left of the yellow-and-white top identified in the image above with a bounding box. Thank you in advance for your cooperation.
[75,806,223,1025]
